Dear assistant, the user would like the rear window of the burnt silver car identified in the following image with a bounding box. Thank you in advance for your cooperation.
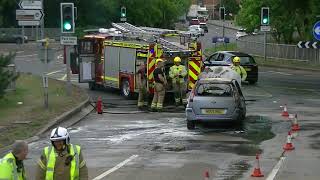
[195,83,233,97]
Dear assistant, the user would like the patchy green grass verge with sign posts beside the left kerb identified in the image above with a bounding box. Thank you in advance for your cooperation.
[0,74,87,148]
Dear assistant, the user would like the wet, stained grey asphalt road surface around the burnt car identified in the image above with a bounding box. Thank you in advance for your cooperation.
[4,24,320,180]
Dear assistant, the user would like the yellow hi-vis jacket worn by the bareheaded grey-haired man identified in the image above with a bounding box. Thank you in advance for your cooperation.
[0,153,26,180]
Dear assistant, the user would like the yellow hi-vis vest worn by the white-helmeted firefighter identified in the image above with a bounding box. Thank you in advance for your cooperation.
[44,144,81,180]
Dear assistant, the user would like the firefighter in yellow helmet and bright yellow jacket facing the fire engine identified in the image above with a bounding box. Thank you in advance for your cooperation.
[169,57,187,106]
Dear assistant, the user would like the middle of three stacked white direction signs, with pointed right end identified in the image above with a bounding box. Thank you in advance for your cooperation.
[16,9,44,21]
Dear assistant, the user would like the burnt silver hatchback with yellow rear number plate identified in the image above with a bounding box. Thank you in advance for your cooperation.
[185,78,246,130]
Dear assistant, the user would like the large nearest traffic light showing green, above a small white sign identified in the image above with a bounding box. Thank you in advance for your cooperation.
[60,3,75,33]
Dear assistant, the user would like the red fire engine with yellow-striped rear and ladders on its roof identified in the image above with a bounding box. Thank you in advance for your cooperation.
[78,23,202,97]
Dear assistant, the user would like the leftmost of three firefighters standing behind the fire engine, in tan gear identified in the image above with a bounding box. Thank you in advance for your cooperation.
[137,62,148,109]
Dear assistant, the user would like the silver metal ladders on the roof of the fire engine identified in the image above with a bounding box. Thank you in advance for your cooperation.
[112,23,187,52]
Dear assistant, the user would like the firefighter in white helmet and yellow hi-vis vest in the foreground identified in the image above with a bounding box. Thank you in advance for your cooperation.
[36,127,88,180]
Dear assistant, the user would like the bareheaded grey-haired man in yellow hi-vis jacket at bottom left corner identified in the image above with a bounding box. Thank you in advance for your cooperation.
[0,141,28,180]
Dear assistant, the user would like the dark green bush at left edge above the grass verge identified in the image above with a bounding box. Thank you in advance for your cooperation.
[0,54,18,99]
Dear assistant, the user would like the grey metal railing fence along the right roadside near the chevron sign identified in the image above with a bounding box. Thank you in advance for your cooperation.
[236,39,320,64]
